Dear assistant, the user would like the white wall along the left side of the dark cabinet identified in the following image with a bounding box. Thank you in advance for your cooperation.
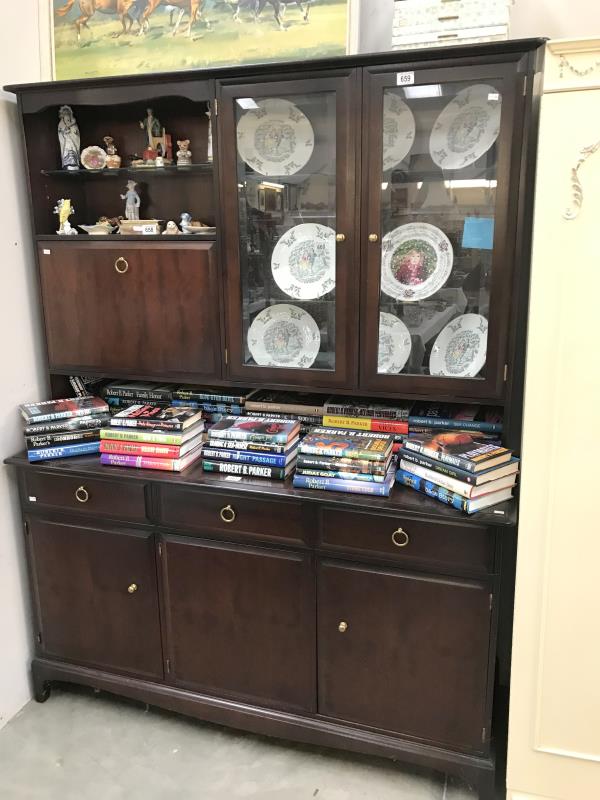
[0,0,46,727]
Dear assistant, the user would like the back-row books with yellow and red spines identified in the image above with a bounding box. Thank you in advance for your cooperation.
[323,397,412,449]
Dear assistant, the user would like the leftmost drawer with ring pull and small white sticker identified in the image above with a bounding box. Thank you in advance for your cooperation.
[24,470,146,522]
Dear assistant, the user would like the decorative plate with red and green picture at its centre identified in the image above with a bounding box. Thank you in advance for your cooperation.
[381,222,453,301]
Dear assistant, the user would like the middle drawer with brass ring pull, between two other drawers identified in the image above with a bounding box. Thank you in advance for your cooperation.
[159,486,305,544]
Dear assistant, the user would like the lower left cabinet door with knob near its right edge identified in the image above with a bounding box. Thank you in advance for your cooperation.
[28,517,163,678]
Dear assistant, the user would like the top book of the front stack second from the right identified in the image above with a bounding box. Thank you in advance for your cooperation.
[300,428,394,461]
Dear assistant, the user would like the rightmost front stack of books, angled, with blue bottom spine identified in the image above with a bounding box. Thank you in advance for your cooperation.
[397,431,519,514]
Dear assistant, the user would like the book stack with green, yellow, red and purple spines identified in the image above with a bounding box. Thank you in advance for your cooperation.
[100,404,204,472]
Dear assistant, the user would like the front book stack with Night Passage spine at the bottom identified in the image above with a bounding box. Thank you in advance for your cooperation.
[202,416,300,480]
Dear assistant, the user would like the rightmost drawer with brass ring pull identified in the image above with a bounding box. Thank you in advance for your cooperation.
[320,509,495,573]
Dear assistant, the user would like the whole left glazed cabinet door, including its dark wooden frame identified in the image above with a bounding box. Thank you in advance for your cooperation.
[219,68,358,387]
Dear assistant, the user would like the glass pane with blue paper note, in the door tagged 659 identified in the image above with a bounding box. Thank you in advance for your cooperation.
[378,81,502,378]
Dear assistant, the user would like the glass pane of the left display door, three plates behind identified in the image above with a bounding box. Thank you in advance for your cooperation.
[236,92,336,370]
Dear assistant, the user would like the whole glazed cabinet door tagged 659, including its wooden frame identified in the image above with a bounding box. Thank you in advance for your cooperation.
[361,65,522,398]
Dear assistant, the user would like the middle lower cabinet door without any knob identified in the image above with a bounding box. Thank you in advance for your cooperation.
[162,536,316,711]
